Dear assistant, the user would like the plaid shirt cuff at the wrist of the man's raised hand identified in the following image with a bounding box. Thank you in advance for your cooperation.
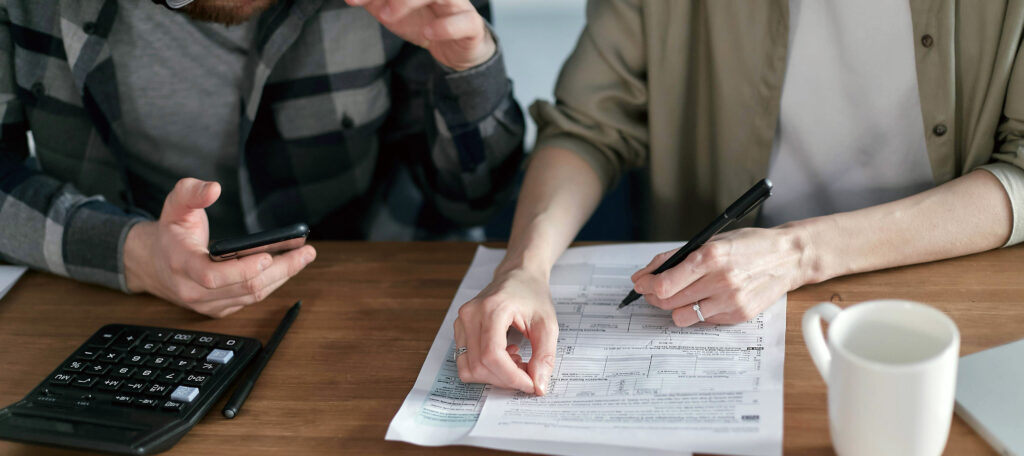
[433,25,512,126]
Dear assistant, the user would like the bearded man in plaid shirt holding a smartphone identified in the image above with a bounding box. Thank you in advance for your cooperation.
[0,0,523,317]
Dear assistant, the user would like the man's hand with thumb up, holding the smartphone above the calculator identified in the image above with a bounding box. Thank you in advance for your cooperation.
[124,178,316,318]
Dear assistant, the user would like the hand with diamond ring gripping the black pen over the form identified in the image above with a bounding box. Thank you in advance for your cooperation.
[632,225,810,326]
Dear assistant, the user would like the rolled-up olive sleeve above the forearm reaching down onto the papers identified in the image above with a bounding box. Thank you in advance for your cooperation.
[530,0,649,189]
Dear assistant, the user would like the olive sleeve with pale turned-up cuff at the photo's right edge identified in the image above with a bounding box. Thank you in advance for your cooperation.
[981,30,1024,247]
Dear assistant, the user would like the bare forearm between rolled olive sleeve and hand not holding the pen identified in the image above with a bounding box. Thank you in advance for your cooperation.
[498,148,603,277]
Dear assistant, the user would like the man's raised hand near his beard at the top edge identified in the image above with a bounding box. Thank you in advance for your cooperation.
[345,0,498,71]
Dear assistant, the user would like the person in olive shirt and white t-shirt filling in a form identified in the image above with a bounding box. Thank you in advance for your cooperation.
[455,0,1024,395]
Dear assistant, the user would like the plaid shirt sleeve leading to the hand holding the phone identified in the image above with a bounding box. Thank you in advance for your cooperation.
[0,5,141,290]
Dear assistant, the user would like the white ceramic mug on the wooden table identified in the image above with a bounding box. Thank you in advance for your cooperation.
[803,299,959,456]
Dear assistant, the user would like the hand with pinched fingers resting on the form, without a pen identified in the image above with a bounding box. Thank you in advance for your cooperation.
[455,270,558,396]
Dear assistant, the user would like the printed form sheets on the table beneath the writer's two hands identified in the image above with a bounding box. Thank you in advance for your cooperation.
[387,243,785,455]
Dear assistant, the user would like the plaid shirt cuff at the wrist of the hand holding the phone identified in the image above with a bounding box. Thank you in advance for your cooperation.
[63,201,144,292]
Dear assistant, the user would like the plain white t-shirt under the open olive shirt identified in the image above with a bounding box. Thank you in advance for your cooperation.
[759,0,935,226]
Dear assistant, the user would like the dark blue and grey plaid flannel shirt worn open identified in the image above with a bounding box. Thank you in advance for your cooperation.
[0,0,523,289]
